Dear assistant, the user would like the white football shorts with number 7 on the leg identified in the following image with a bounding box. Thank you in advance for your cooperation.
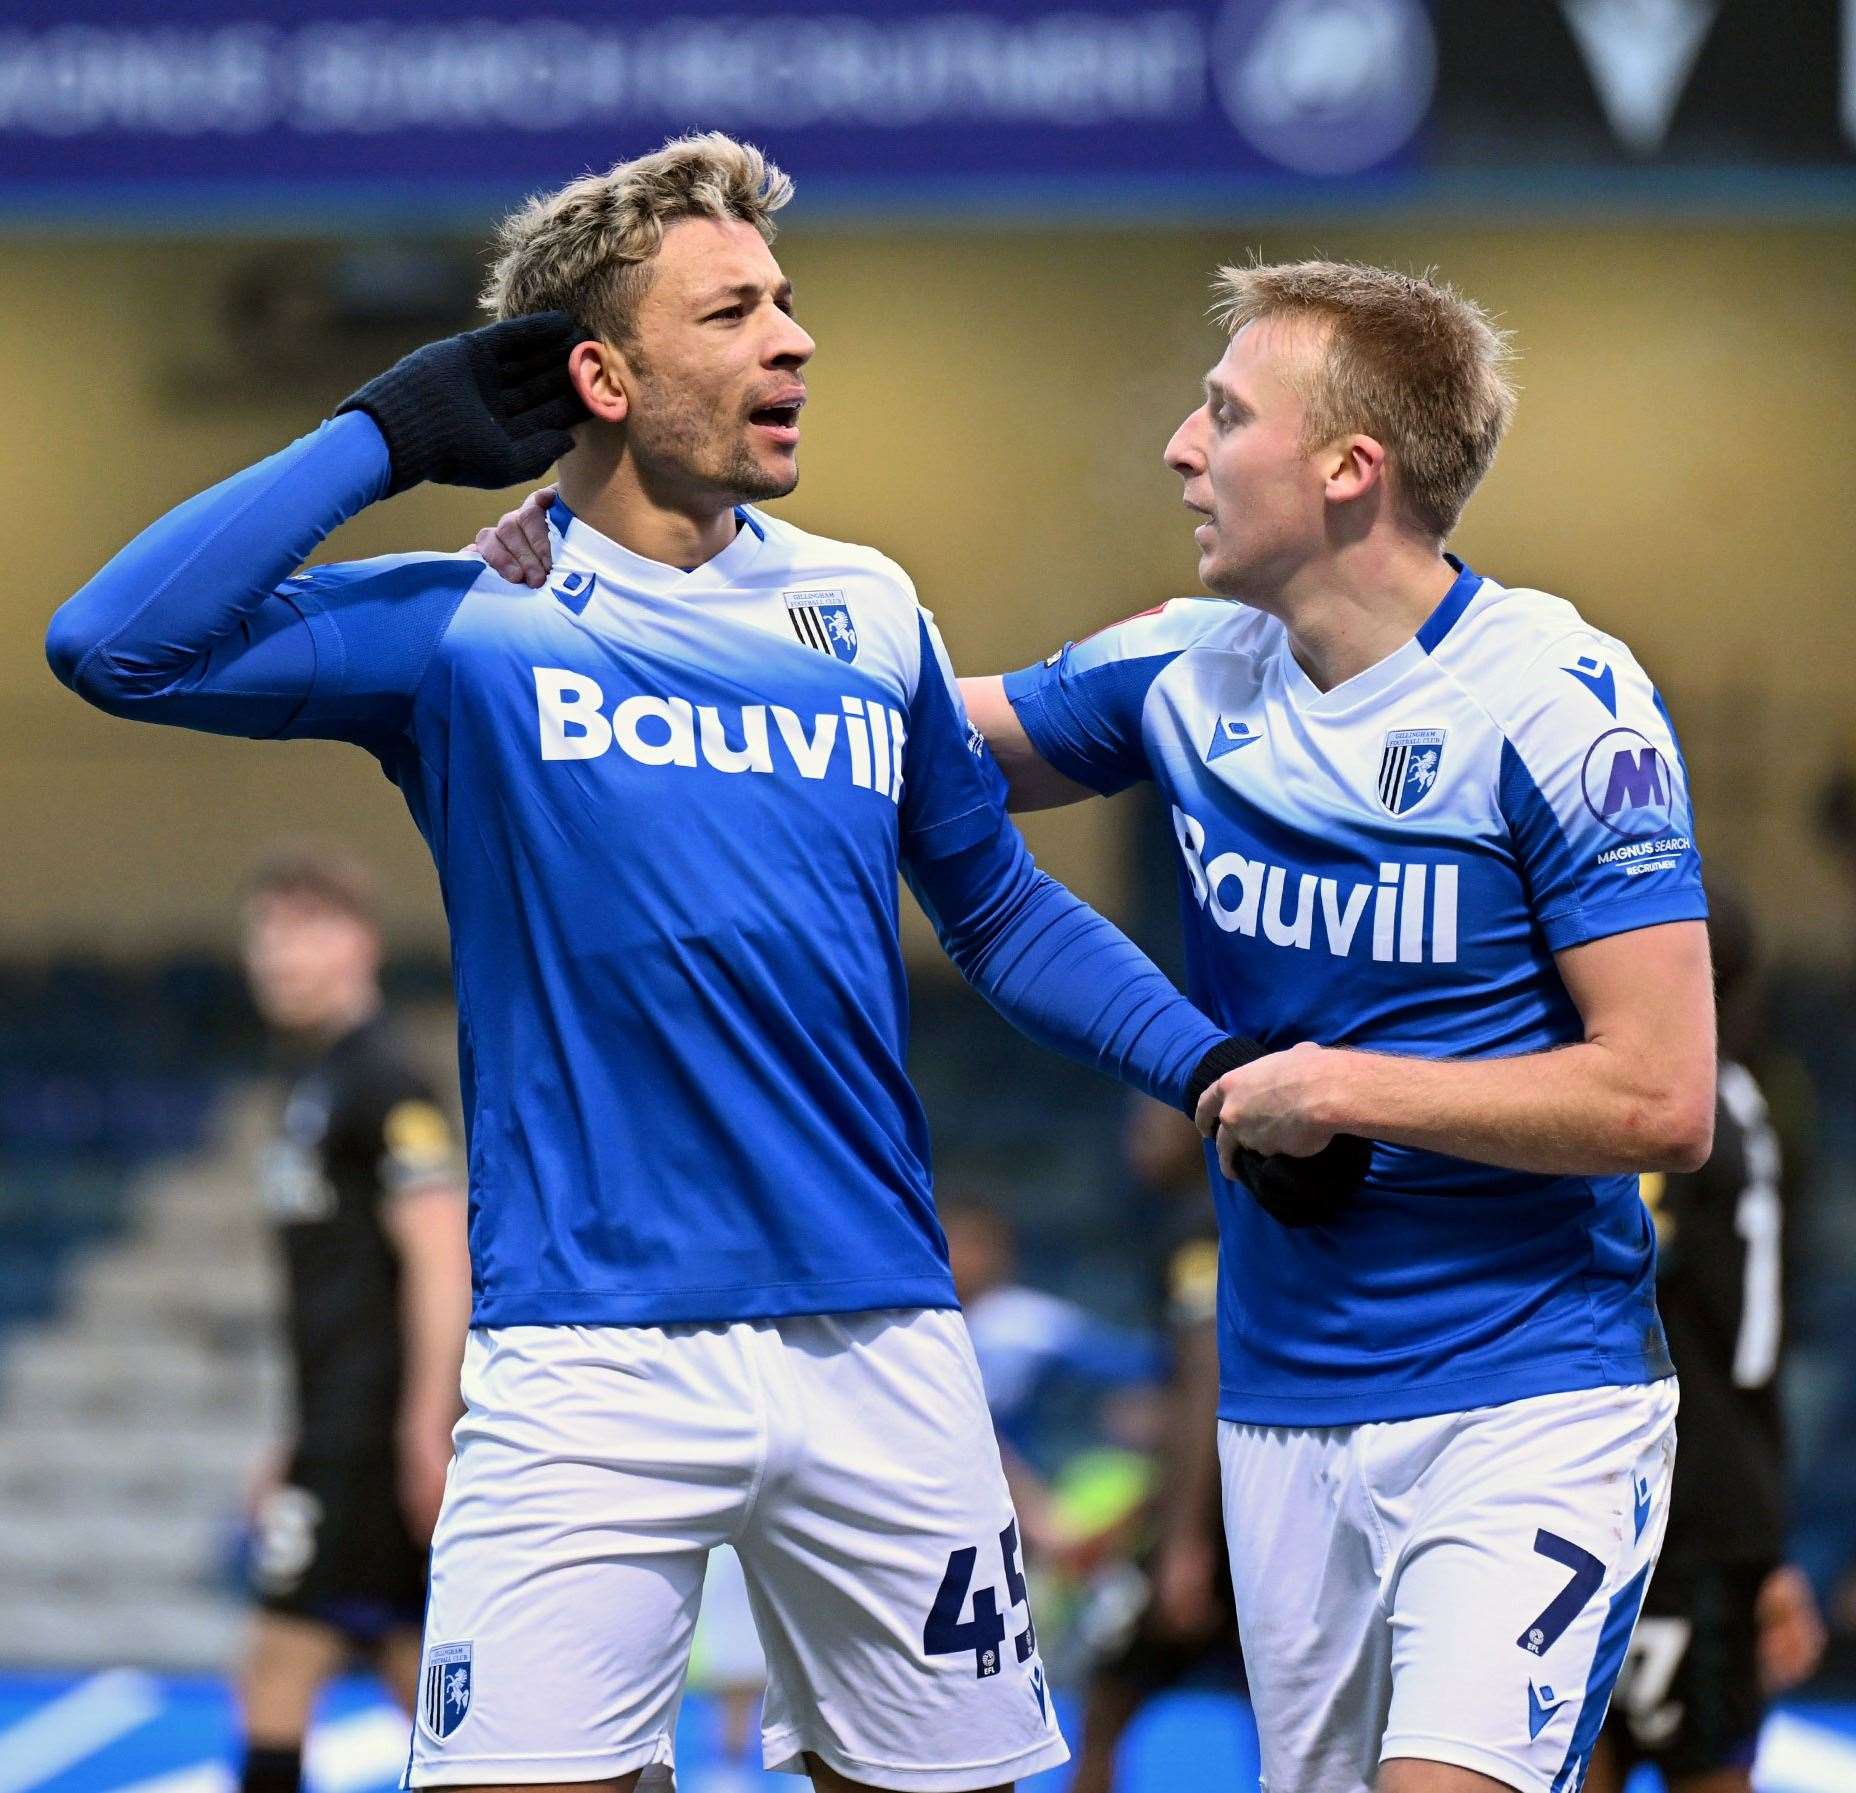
[1218,1379,1676,1793]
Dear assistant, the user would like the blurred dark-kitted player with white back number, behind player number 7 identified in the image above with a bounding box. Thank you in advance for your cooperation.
[1589,882,1823,1793]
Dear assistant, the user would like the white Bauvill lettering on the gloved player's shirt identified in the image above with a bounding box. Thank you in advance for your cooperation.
[535,666,908,804]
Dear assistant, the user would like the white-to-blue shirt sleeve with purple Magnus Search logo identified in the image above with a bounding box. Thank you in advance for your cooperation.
[1433,585,1708,952]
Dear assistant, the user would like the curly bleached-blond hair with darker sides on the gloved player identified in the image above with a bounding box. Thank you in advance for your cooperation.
[481,130,793,343]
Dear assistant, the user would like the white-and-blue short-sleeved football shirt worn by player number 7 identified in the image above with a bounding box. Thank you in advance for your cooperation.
[1006,568,1706,1425]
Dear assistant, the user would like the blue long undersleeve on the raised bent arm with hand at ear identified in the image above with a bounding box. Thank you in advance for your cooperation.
[45,412,388,735]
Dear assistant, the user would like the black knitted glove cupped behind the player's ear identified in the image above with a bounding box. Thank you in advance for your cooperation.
[336,312,586,497]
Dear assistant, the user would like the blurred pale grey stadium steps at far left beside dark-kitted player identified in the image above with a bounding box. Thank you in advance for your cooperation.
[0,1093,286,1670]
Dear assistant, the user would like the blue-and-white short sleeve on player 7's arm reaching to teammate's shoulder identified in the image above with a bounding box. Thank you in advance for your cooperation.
[1004,598,1275,796]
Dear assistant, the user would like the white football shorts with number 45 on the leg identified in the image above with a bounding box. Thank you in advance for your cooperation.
[405,1309,1069,1793]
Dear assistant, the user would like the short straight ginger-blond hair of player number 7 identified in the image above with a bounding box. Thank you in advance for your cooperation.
[1212,262,1514,536]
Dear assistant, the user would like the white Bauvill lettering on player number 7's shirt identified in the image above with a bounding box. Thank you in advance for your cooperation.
[1173,804,1457,965]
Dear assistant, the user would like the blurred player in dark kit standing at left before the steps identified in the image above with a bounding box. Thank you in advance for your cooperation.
[239,848,470,1793]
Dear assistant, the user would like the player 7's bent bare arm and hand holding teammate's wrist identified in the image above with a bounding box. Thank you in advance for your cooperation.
[1199,921,1715,1177]
